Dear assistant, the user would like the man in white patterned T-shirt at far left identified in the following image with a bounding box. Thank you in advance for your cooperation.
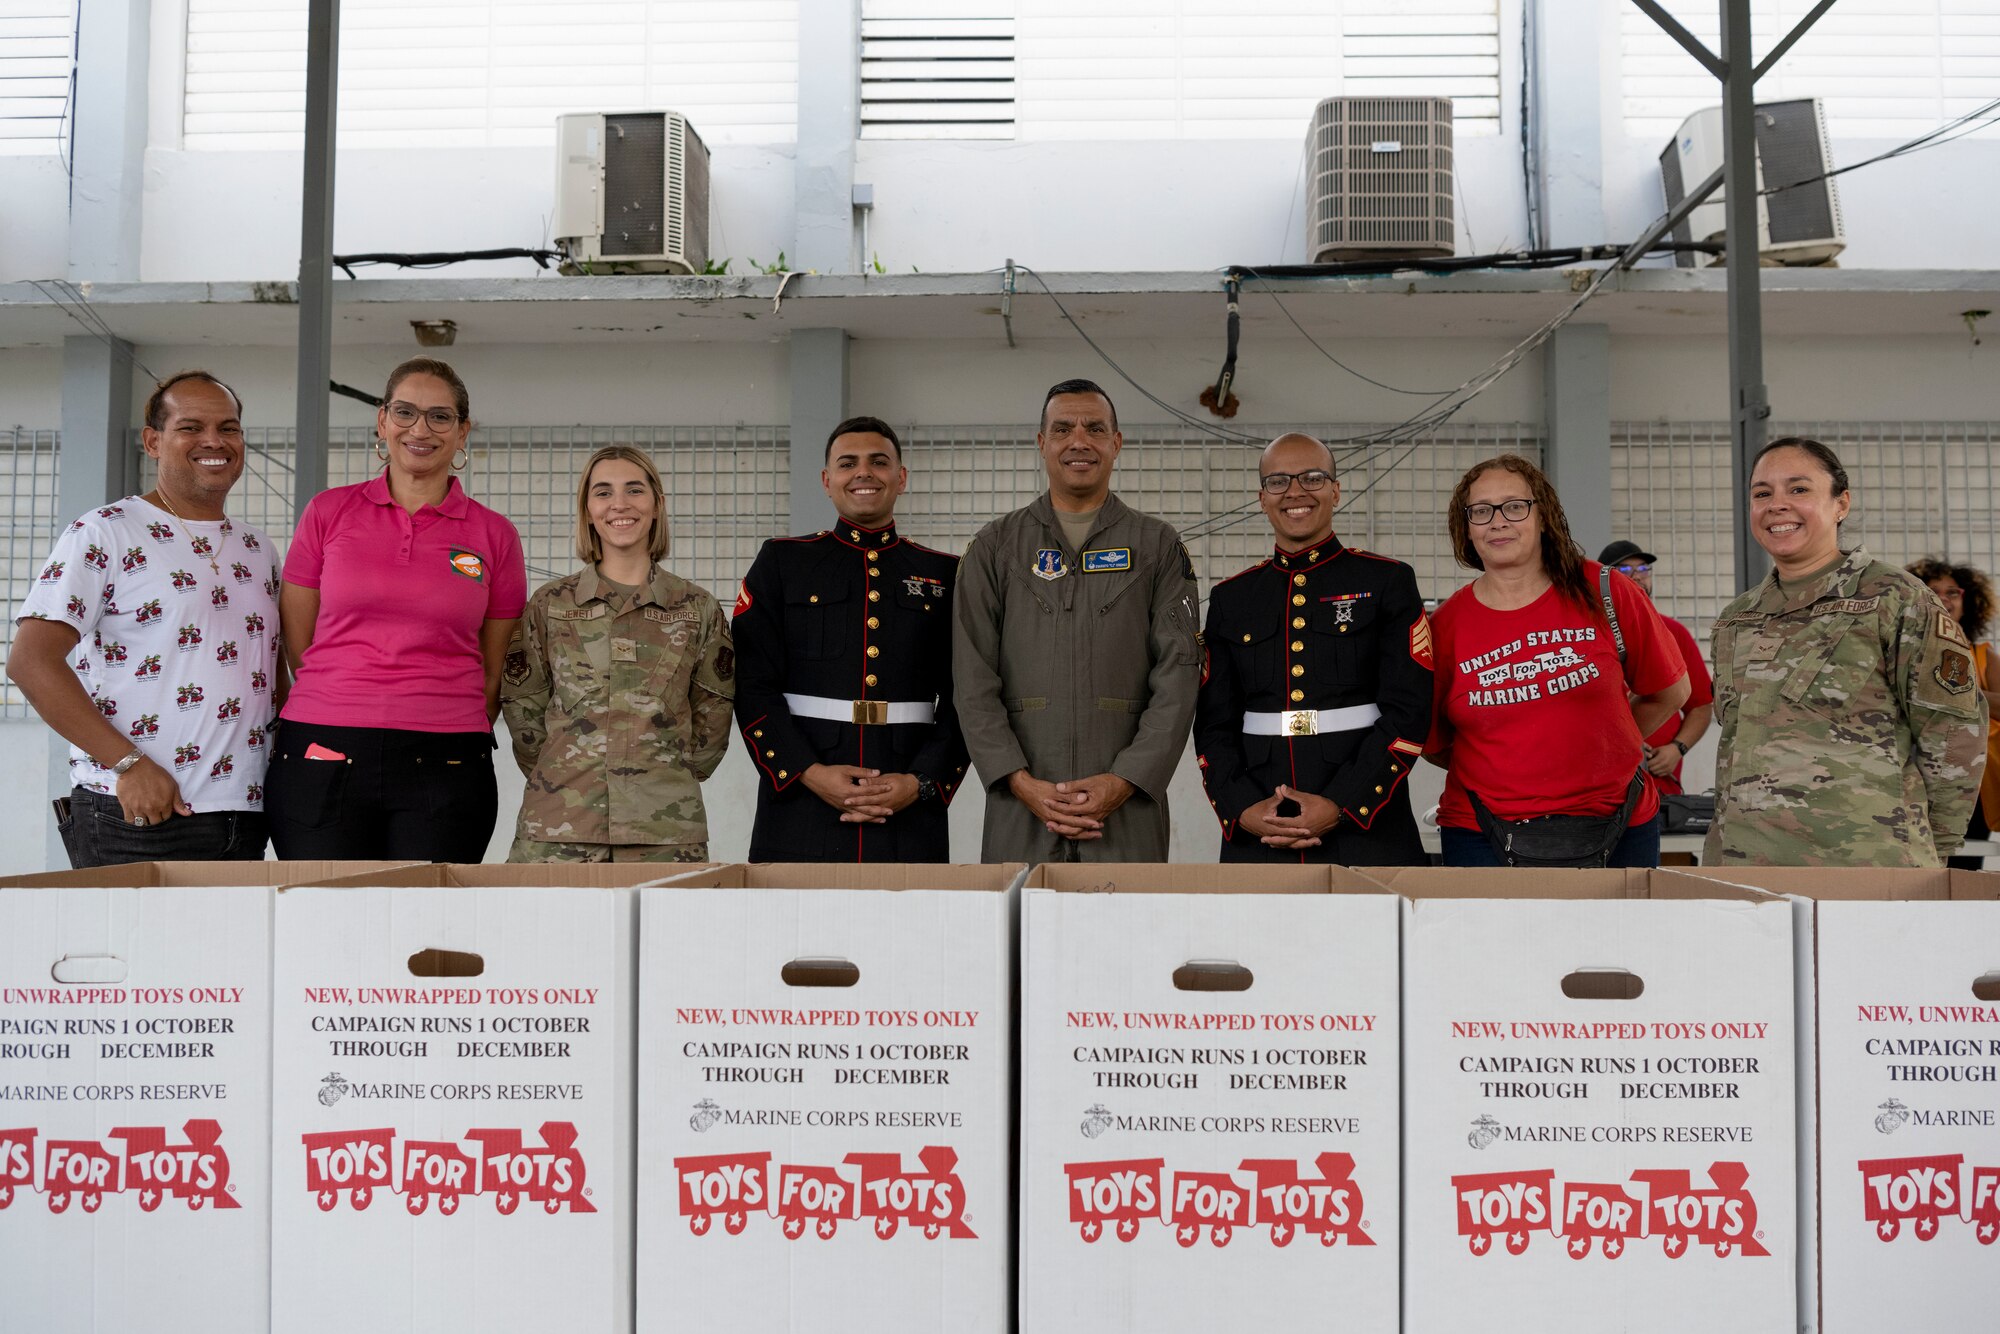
[6,370,284,868]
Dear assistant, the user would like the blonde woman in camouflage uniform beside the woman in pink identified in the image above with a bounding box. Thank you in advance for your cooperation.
[500,444,736,862]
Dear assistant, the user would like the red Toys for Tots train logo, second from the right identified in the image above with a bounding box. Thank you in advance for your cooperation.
[1452,1162,1770,1260]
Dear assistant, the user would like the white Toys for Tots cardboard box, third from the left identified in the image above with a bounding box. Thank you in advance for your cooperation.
[638,866,1022,1334]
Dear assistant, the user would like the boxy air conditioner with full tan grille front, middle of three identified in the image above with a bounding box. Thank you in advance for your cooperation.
[1306,98,1458,264]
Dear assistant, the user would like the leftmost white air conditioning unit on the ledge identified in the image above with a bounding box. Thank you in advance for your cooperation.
[550,112,708,274]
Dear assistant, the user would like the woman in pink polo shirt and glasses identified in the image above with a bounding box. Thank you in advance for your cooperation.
[264,356,528,862]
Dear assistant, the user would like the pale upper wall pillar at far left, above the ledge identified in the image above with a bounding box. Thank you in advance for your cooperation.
[68,0,152,282]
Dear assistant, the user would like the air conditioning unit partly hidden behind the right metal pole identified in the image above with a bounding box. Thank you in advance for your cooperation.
[1660,98,1848,268]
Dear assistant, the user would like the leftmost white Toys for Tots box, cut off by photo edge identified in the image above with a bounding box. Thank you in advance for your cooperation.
[0,862,394,1334]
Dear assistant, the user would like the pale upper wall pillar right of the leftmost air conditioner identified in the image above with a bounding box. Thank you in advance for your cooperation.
[788,0,862,272]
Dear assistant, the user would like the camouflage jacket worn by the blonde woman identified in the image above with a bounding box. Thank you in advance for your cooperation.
[500,570,736,844]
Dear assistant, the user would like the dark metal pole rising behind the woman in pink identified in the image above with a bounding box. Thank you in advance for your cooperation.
[292,0,340,514]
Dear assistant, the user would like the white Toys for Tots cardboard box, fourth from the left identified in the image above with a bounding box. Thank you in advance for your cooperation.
[1020,864,1400,1334]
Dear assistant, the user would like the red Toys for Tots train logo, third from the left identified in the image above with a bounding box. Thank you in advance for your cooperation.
[674,1144,976,1242]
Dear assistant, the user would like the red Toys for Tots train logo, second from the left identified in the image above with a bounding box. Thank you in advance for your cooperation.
[300,1120,598,1214]
